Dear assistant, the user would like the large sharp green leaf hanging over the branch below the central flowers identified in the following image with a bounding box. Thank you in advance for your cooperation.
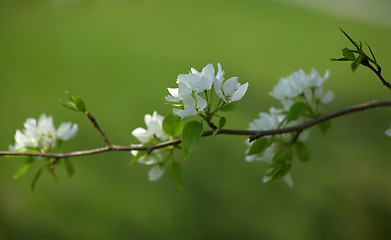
[182,121,203,159]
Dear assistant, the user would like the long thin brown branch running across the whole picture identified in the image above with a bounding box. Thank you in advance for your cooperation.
[0,101,391,159]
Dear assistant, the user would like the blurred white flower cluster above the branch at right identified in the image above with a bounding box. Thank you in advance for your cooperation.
[270,69,334,110]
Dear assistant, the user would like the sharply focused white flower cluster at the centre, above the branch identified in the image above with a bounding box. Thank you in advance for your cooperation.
[166,63,248,119]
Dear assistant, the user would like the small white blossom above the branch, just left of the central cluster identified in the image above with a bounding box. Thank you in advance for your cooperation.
[132,111,168,143]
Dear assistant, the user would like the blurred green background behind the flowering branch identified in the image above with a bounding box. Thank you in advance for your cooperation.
[0,0,391,240]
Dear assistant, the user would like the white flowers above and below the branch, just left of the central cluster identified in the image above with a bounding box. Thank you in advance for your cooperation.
[131,111,169,181]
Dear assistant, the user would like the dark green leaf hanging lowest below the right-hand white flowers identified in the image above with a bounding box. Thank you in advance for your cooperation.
[262,146,293,183]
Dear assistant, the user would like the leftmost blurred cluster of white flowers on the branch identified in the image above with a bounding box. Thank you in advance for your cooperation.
[9,114,78,152]
